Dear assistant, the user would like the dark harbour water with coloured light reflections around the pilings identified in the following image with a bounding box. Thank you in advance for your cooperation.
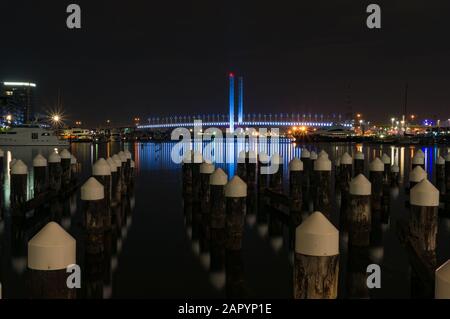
[0,142,450,298]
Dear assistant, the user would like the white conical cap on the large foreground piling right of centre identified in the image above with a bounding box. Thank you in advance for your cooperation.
[295,212,339,256]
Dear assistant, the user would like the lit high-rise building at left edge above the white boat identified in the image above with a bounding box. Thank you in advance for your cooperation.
[0,82,36,124]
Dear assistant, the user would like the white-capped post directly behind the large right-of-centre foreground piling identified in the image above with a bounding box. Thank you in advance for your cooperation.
[314,154,331,217]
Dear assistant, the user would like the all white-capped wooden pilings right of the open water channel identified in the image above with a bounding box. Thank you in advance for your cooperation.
[182,149,450,298]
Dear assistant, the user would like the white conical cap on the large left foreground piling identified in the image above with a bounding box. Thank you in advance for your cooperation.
[28,222,76,270]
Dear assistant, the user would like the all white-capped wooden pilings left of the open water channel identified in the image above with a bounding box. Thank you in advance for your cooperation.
[0,150,135,299]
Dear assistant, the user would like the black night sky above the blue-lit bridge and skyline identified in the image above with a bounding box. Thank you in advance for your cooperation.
[0,0,450,126]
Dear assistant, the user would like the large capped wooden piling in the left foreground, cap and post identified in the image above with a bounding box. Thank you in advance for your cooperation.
[28,222,76,299]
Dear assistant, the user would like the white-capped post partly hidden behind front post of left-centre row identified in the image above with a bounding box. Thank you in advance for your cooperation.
[92,158,112,231]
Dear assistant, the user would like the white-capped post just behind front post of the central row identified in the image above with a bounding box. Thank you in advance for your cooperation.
[209,168,228,229]
